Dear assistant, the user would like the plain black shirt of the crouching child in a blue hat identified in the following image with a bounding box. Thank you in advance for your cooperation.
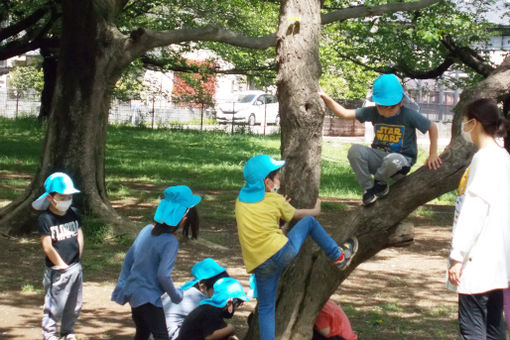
[177,304,227,340]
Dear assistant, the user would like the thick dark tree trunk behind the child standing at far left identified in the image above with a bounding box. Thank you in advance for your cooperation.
[0,0,137,234]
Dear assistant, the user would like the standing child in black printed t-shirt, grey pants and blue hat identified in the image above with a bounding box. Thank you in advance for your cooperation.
[32,172,83,340]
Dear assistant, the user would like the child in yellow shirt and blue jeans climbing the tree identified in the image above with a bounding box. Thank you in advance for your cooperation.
[235,155,358,340]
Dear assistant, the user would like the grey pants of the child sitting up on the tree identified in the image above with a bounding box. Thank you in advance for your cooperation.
[347,144,412,191]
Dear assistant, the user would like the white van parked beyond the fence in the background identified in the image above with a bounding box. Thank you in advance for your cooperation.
[216,91,280,125]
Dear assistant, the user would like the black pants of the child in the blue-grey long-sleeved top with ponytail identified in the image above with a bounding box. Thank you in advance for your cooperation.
[131,303,169,340]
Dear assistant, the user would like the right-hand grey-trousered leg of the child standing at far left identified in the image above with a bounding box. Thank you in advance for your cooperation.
[60,263,83,336]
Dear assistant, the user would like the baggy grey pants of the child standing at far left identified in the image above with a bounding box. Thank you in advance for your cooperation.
[42,263,83,340]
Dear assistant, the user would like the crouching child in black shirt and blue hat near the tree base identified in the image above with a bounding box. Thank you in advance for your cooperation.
[177,277,249,340]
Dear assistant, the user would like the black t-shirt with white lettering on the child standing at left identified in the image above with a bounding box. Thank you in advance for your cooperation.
[39,208,81,267]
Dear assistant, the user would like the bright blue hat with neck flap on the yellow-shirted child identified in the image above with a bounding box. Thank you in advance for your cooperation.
[238,155,285,203]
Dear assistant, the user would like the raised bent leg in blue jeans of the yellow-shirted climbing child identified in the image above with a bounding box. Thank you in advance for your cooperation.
[287,216,342,260]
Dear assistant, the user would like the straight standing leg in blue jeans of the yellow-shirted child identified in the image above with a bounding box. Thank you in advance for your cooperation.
[255,242,297,340]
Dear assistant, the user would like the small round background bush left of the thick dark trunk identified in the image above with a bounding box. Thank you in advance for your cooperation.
[9,65,44,96]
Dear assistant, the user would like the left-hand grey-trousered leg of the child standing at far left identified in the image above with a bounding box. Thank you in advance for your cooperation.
[41,268,67,339]
